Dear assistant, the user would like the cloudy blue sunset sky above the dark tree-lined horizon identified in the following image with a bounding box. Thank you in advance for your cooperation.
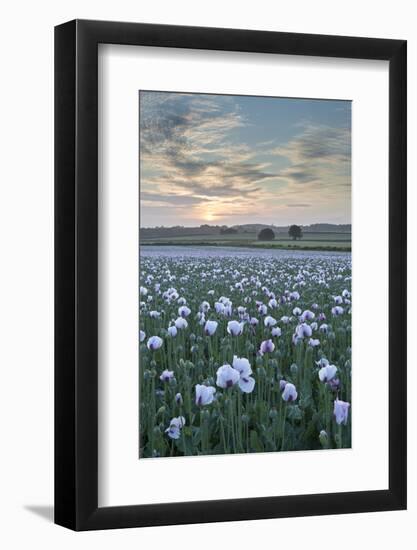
[139,91,351,227]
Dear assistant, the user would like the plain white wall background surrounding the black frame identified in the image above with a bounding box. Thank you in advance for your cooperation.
[0,0,417,550]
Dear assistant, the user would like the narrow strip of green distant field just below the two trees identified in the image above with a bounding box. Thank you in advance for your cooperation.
[140,233,351,250]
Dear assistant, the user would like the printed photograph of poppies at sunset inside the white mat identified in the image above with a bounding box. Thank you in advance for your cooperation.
[139,90,352,458]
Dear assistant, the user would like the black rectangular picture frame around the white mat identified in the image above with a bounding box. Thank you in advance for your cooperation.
[55,20,407,531]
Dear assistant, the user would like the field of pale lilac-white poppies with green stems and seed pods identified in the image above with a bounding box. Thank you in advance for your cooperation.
[139,247,352,458]
